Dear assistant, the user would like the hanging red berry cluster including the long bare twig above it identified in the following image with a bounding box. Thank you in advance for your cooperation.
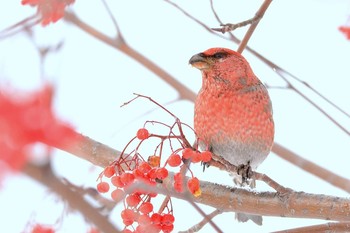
[97,94,212,233]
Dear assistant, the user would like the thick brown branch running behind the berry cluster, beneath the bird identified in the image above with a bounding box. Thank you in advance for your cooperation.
[41,134,350,221]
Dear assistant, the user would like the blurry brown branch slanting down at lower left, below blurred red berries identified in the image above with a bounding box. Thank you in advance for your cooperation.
[22,163,120,233]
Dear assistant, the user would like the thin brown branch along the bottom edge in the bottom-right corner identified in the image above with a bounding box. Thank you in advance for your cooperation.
[274,222,350,233]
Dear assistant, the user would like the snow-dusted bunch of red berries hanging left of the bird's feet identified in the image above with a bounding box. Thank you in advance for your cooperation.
[97,125,211,233]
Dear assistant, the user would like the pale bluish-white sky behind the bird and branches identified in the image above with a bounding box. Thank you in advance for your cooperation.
[0,0,350,233]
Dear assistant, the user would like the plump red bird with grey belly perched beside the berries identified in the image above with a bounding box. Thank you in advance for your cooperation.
[189,48,274,225]
